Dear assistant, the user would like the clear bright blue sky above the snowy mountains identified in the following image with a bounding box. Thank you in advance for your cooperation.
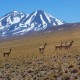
[0,0,80,22]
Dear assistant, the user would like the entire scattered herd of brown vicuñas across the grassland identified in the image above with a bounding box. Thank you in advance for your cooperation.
[3,40,74,57]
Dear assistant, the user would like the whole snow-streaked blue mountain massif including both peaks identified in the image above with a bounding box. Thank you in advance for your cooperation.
[0,10,64,37]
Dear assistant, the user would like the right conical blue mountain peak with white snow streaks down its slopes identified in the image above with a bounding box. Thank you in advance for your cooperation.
[14,10,63,35]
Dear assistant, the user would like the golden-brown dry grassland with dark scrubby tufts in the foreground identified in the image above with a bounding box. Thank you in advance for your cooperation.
[0,30,80,80]
